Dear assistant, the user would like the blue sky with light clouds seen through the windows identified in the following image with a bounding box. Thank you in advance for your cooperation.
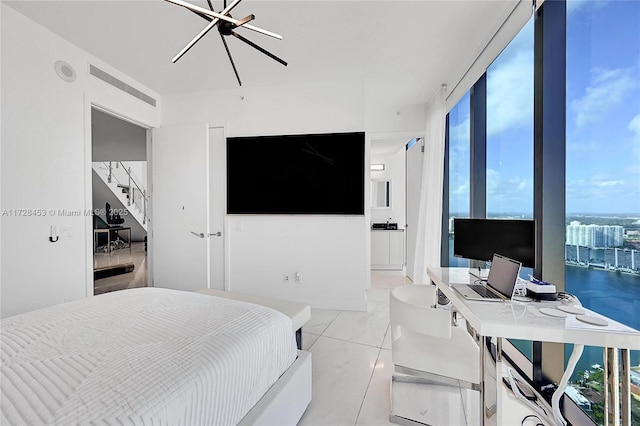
[450,0,640,214]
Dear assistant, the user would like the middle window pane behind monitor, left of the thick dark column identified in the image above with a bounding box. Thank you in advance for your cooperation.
[487,20,534,360]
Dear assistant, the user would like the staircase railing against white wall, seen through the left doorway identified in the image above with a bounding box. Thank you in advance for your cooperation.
[92,161,149,231]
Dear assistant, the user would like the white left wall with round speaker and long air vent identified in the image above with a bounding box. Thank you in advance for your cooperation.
[0,3,160,317]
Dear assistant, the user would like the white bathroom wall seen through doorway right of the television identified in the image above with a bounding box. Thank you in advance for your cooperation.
[371,146,408,228]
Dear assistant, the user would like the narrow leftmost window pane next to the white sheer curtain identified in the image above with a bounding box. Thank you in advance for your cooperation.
[449,92,471,267]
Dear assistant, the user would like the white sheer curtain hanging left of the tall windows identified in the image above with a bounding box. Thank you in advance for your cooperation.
[412,86,447,284]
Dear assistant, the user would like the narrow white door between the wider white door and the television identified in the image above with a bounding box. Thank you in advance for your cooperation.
[209,127,227,290]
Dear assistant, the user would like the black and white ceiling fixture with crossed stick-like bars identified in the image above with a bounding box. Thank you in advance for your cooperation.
[165,0,287,86]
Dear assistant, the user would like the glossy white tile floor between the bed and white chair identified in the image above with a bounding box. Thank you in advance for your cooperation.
[299,271,407,426]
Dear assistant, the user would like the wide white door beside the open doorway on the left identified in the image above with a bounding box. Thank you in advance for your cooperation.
[151,124,210,291]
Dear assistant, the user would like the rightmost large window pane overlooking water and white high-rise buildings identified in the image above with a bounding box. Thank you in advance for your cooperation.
[565,0,640,424]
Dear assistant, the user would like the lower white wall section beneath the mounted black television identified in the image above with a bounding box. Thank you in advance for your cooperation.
[227,215,369,310]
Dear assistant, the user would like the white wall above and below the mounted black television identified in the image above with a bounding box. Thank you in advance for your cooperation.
[162,82,378,310]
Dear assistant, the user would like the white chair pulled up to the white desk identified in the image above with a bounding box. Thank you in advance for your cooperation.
[389,284,480,424]
